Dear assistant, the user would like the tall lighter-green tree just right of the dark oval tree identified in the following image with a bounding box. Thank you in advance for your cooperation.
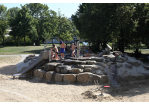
[26,3,53,45]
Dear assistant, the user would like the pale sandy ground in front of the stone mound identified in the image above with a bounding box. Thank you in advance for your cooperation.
[0,58,149,102]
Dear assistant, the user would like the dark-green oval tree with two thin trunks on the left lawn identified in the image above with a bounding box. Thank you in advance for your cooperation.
[10,6,34,47]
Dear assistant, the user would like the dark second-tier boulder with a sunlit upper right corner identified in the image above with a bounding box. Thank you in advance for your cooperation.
[56,65,71,74]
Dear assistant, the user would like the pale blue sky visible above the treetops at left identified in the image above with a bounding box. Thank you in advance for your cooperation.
[0,2,81,18]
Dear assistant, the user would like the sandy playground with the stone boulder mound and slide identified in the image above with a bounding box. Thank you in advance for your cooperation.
[0,42,149,102]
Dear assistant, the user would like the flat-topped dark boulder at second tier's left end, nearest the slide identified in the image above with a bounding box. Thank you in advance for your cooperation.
[44,63,62,71]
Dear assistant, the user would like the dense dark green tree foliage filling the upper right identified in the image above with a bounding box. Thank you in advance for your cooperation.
[72,3,148,52]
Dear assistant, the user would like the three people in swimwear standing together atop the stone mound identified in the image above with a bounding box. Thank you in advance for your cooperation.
[50,41,76,59]
